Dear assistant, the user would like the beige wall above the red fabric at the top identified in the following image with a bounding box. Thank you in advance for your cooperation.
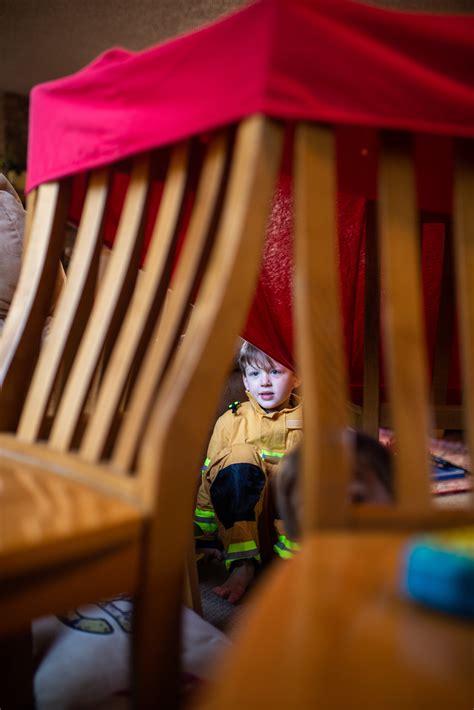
[0,0,474,94]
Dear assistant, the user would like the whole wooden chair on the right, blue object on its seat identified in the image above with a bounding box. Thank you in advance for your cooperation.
[195,124,474,710]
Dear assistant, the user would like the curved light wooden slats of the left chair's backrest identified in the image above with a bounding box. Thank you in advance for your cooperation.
[0,119,278,458]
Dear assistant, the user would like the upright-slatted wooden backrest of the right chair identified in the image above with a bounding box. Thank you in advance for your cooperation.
[294,124,474,532]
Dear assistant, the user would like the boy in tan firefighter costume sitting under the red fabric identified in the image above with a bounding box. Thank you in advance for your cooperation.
[194,342,303,603]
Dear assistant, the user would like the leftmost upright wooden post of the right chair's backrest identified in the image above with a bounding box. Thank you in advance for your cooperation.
[295,124,350,533]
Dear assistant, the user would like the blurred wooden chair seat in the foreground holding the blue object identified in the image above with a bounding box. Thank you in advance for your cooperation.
[199,532,473,710]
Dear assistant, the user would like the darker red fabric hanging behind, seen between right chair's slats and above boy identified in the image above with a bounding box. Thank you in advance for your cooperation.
[243,127,460,404]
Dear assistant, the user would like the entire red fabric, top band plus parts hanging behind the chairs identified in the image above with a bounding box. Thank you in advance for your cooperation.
[28,0,474,398]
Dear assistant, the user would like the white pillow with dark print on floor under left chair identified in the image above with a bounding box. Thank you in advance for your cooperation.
[33,598,230,710]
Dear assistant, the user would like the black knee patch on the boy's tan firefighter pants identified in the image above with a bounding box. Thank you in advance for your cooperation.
[210,463,265,530]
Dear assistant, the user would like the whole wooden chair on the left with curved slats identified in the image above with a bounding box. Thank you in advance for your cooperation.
[0,116,282,708]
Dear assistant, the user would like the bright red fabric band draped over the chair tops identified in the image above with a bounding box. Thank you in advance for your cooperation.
[28,0,474,189]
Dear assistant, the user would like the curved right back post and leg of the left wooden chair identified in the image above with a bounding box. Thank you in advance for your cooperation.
[134,116,282,710]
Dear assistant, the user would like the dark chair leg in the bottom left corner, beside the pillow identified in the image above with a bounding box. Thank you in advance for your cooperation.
[0,628,35,710]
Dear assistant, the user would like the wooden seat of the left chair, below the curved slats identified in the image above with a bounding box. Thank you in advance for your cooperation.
[0,442,145,633]
